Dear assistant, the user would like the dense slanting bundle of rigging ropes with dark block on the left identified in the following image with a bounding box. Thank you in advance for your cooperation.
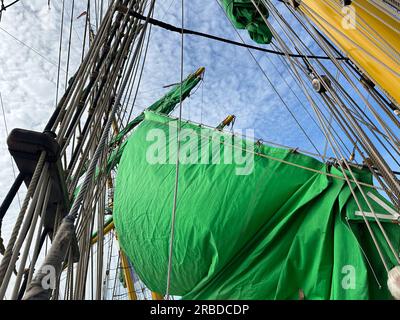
[0,0,155,299]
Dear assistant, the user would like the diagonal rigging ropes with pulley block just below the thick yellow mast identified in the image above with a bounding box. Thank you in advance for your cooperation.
[242,0,400,208]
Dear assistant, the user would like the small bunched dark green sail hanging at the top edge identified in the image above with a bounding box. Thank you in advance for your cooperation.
[222,0,272,44]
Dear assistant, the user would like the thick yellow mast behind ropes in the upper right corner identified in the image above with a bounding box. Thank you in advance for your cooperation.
[298,0,400,106]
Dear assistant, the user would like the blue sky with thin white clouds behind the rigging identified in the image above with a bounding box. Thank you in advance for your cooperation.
[0,0,398,241]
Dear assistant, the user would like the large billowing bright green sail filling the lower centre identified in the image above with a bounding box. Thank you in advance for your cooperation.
[114,112,400,299]
